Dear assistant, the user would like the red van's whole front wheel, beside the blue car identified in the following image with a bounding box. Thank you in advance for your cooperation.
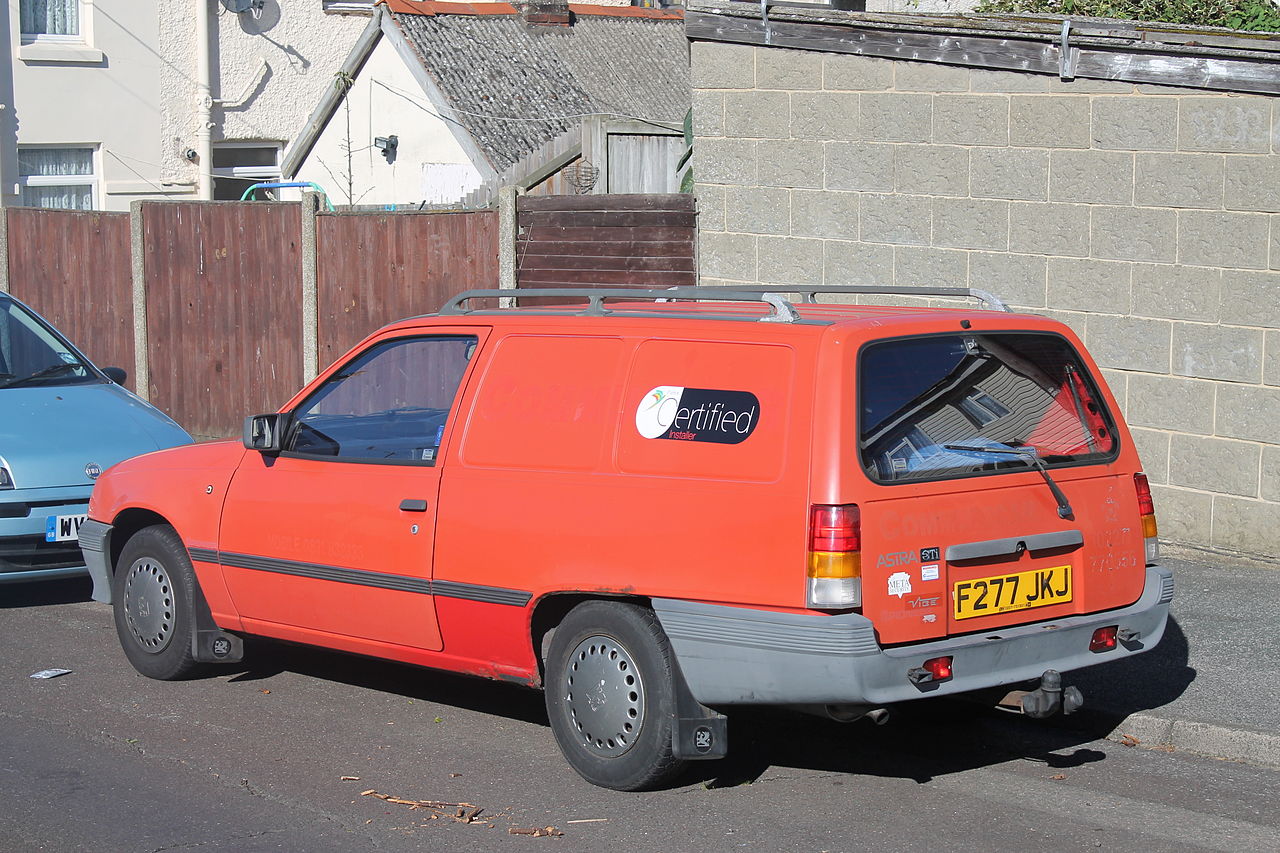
[111,524,201,681]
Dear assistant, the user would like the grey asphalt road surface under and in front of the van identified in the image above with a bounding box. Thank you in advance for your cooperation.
[0,573,1280,853]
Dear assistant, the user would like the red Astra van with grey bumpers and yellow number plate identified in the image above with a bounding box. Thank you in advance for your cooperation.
[81,287,1172,790]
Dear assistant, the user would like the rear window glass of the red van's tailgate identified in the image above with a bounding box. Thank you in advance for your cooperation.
[858,333,1116,483]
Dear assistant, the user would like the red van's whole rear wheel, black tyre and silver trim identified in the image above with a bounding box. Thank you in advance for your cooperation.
[545,601,686,790]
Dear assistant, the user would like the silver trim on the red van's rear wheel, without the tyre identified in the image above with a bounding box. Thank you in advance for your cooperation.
[562,634,645,758]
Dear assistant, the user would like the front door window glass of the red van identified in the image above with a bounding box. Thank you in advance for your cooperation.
[284,336,476,465]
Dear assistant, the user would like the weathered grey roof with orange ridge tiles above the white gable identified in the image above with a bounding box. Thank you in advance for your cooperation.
[388,0,690,172]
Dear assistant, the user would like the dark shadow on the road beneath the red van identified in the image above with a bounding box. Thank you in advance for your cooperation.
[221,619,1196,788]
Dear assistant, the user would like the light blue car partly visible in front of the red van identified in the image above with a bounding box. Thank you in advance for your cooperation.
[0,293,191,583]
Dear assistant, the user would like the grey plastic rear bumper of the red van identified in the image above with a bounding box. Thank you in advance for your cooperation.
[653,566,1174,706]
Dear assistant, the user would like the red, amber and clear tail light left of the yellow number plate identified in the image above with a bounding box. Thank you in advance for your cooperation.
[805,503,863,610]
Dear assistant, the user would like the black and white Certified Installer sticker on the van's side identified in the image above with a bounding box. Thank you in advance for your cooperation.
[636,386,760,444]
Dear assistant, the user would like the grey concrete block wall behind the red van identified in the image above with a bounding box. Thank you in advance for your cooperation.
[692,41,1280,557]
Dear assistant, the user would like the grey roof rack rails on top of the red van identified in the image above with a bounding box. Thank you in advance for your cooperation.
[439,284,1012,323]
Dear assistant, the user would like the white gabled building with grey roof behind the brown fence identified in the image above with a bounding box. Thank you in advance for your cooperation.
[282,0,690,206]
